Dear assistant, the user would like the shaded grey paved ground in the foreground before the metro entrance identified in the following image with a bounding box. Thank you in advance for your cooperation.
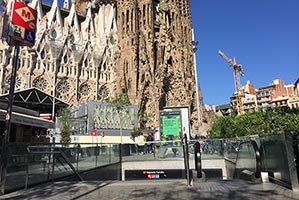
[0,179,299,200]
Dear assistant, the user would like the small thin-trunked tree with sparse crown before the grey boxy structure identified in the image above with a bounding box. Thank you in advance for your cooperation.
[107,93,130,144]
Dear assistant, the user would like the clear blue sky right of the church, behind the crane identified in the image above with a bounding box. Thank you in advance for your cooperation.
[190,0,299,105]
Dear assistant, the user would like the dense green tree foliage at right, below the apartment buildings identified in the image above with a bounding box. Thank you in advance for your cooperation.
[209,108,299,138]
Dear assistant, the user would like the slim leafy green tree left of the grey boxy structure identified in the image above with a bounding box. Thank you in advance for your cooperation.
[58,108,72,144]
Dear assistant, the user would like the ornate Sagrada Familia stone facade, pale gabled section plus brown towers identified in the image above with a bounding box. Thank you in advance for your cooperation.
[0,0,202,130]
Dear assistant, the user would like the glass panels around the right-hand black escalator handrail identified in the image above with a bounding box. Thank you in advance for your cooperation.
[235,134,296,188]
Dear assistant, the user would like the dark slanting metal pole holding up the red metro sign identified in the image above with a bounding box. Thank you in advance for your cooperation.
[0,41,20,194]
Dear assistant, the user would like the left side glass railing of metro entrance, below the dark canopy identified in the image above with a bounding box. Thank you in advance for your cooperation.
[5,143,120,192]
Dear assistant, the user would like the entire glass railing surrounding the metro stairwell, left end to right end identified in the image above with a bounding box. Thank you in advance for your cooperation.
[5,135,296,191]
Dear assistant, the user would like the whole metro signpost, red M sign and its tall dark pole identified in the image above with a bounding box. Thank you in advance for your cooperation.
[0,0,37,195]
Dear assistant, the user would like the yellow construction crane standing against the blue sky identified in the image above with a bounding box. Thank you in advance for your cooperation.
[218,51,244,115]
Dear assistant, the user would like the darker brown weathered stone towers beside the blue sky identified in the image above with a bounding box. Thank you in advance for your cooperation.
[117,0,196,126]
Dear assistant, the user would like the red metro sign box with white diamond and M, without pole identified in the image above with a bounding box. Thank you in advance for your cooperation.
[7,1,37,46]
